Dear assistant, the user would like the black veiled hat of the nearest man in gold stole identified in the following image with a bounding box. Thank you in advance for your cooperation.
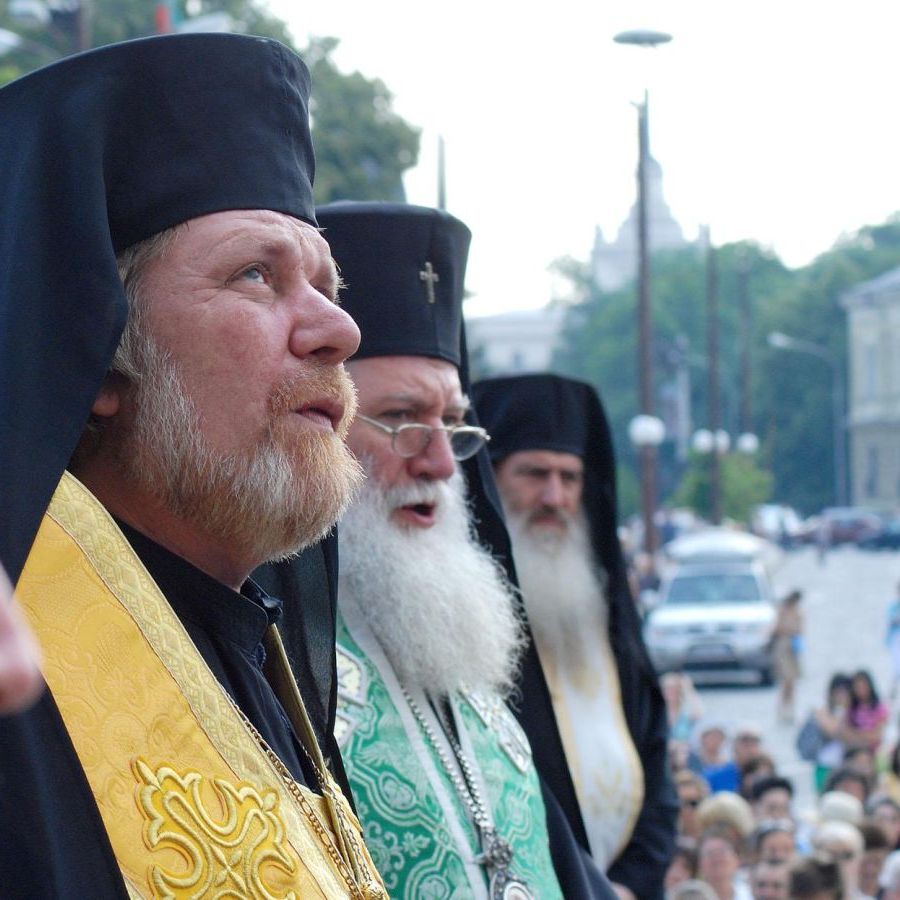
[0,34,315,582]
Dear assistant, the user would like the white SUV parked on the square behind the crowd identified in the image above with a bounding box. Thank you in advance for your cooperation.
[644,559,775,684]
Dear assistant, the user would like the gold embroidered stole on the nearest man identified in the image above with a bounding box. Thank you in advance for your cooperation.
[17,473,377,900]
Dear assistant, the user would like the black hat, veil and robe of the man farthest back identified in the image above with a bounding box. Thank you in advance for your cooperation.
[470,374,678,900]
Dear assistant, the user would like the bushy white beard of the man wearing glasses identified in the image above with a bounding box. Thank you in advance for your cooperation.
[340,468,524,697]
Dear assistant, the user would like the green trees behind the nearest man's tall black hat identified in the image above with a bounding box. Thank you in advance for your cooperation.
[0,0,419,203]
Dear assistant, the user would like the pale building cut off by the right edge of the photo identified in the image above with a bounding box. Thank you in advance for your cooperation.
[841,268,900,510]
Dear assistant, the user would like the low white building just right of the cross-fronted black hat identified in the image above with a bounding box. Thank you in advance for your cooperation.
[466,307,565,376]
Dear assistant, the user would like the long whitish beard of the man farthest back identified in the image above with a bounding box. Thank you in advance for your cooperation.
[507,512,609,663]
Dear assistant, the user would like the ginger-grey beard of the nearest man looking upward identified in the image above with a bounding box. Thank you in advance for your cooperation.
[117,337,362,564]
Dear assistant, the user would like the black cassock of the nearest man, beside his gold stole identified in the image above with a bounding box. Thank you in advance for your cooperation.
[0,526,350,900]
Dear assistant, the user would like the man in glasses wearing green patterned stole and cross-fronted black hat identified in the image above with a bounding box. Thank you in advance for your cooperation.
[306,203,610,900]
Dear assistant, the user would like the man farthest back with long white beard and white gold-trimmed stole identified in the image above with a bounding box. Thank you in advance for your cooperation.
[472,374,676,900]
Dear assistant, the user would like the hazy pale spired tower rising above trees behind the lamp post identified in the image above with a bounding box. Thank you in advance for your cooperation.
[591,156,691,291]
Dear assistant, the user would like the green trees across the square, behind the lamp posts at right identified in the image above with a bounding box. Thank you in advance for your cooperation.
[553,216,900,513]
